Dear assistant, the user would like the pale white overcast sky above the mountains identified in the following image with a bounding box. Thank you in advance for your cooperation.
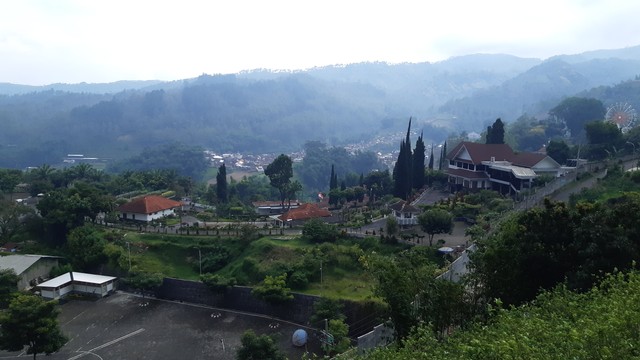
[0,0,640,85]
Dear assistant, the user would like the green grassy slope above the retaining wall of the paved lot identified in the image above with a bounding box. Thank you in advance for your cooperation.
[120,232,416,300]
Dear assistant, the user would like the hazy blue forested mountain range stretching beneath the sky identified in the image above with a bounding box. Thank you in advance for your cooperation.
[0,45,640,168]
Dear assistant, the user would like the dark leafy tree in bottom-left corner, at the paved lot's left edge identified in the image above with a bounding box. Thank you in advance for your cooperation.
[0,294,67,360]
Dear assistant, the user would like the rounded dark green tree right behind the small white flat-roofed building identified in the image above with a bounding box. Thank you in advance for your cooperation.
[67,225,106,271]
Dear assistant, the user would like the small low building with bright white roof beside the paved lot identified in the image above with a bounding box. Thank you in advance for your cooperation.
[37,272,117,299]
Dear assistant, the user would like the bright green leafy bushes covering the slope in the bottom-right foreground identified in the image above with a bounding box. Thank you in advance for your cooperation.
[364,271,640,360]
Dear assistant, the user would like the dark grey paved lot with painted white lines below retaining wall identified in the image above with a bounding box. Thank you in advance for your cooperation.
[0,293,319,360]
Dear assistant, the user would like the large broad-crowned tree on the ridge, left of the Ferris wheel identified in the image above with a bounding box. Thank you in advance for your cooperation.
[549,97,606,139]
